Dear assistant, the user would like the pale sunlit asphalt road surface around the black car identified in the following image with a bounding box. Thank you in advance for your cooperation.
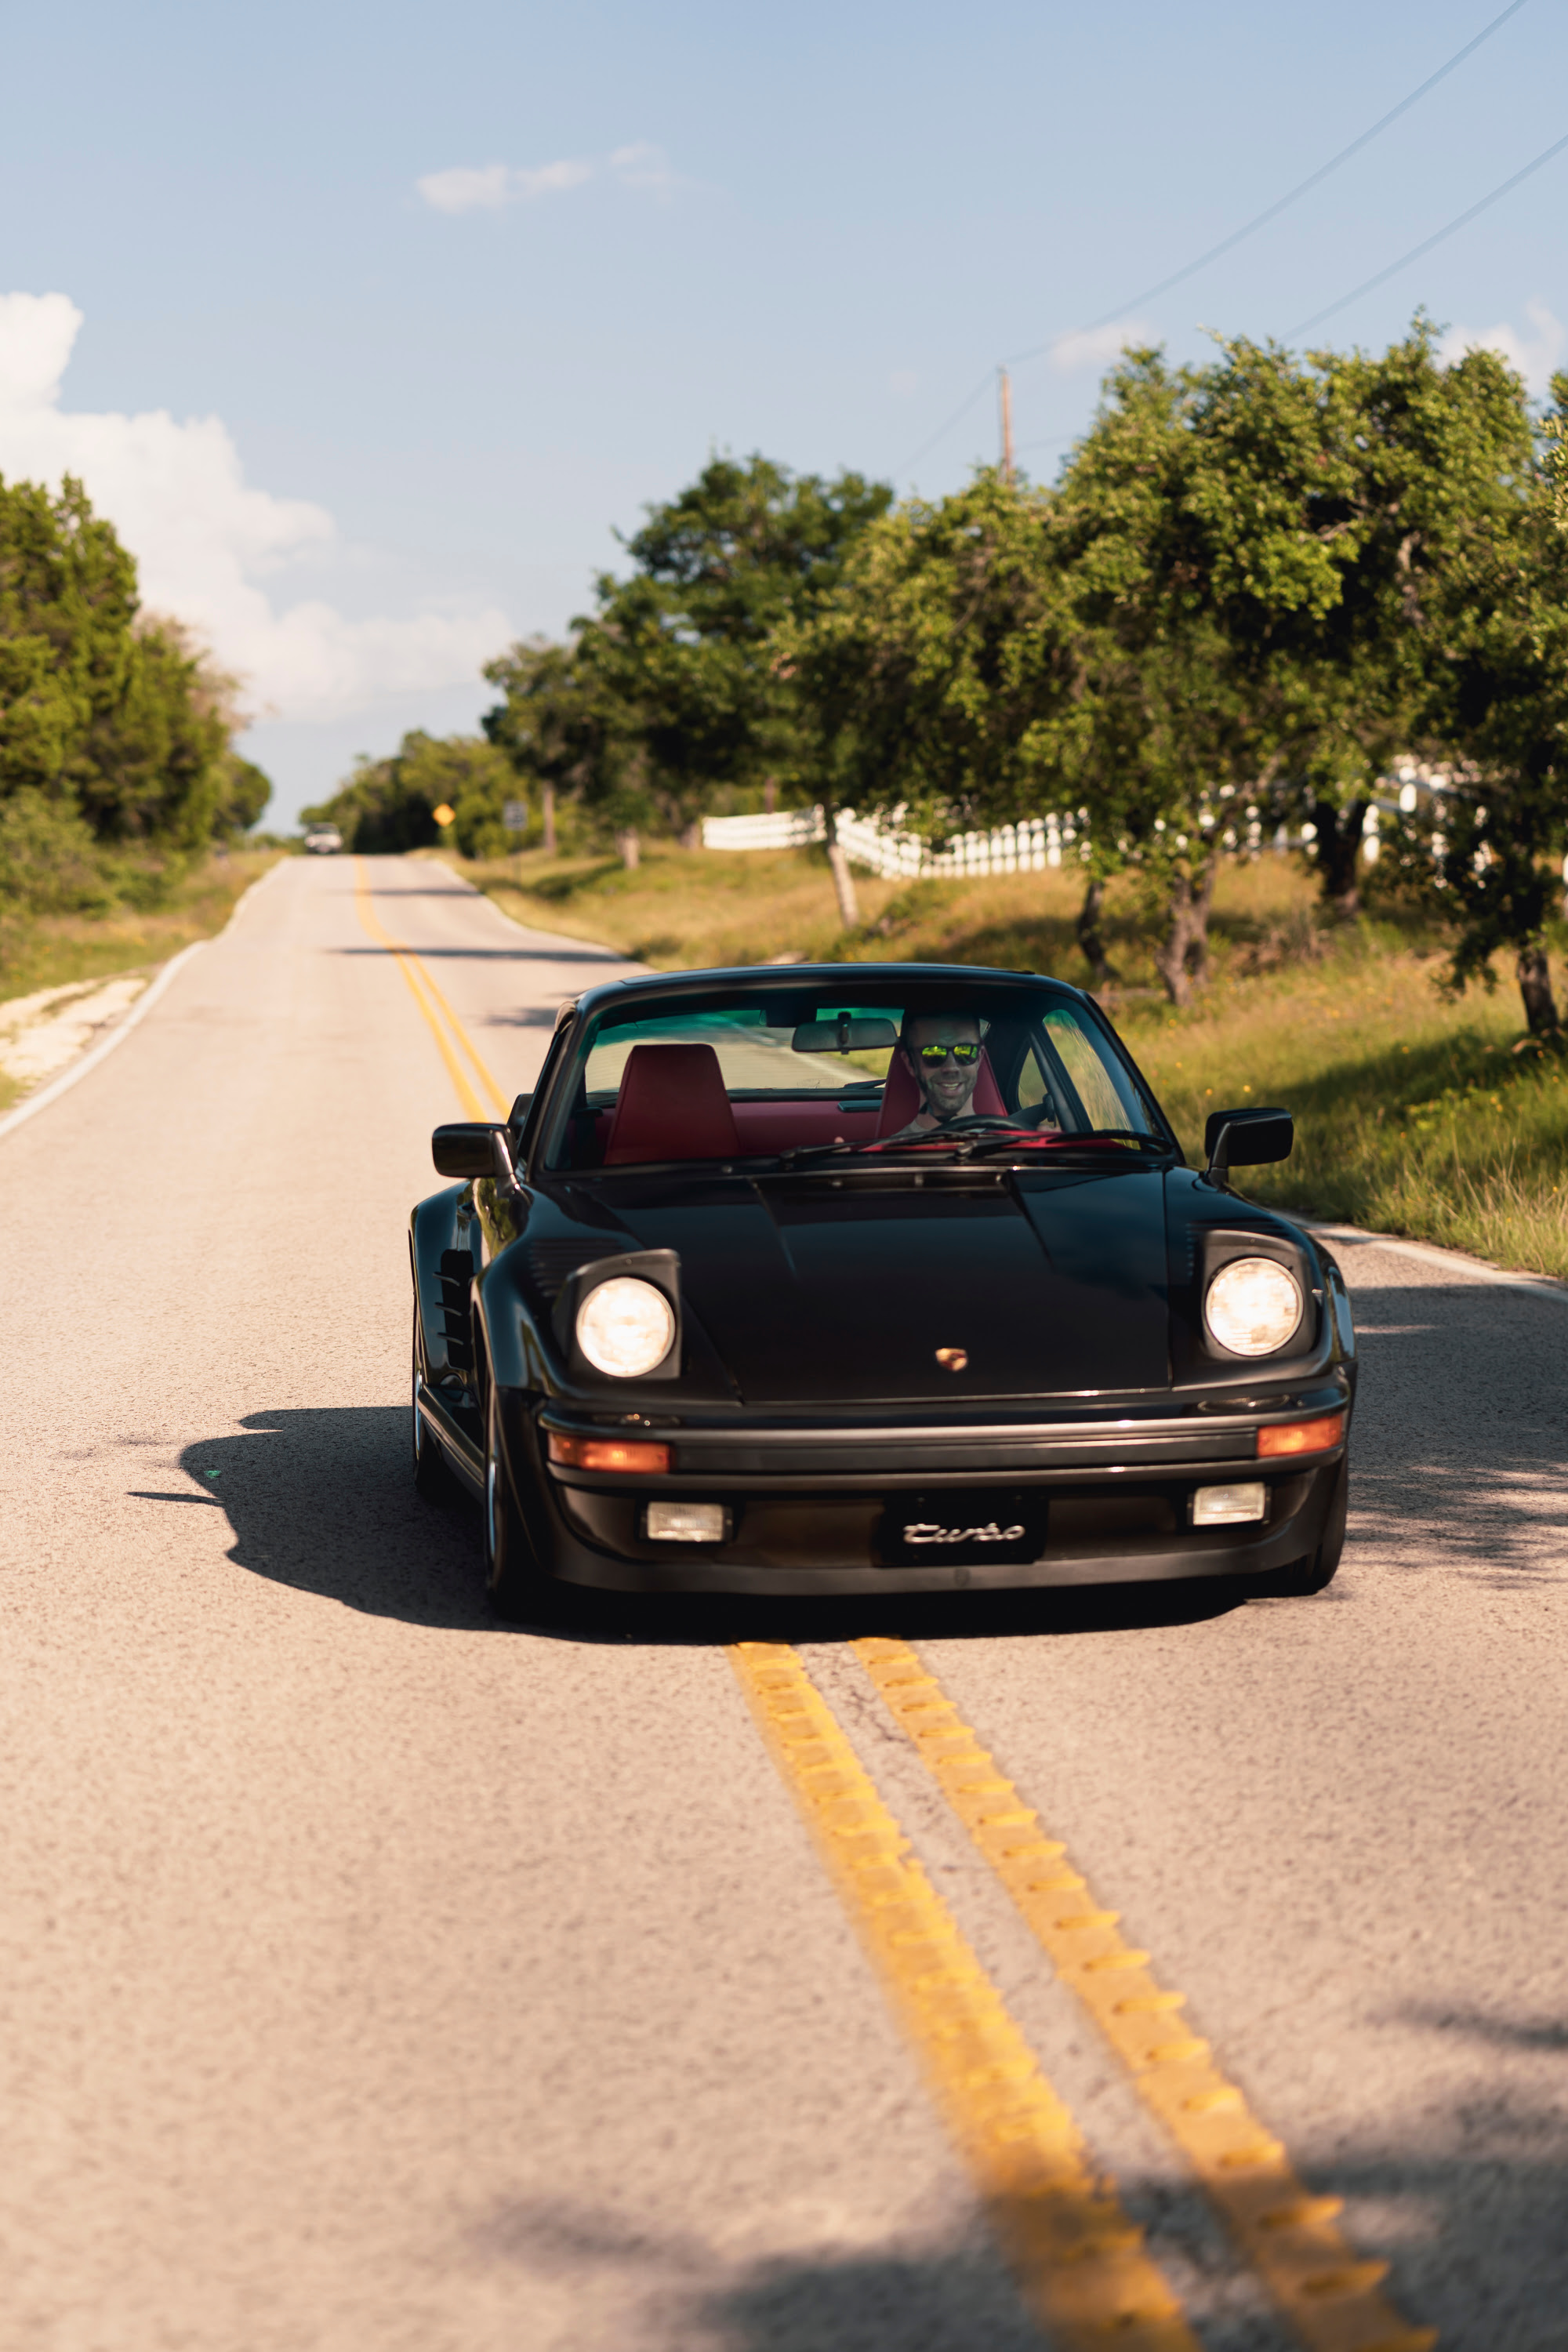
[0,861,1568,2352]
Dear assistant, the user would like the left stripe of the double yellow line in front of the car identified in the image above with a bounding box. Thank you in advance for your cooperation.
[729,1642,1199,2352]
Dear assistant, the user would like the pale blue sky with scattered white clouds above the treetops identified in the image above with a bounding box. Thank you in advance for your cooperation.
[0,0,1568,823]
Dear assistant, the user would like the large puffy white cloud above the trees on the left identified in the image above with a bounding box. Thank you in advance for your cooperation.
[0,294,510,720]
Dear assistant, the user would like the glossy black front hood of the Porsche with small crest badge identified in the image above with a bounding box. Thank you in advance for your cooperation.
[616,1167,1171,1404]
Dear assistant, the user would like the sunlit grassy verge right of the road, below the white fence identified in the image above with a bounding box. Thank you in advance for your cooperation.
[454,849,1568,1277]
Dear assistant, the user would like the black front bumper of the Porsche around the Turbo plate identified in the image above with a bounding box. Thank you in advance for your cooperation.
[501,1378,1352,1595]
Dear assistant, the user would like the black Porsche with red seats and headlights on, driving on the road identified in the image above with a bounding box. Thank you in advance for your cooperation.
[412,964,1354,1618]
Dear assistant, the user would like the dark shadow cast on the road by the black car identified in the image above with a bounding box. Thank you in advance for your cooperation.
[177,1404,1246,1646]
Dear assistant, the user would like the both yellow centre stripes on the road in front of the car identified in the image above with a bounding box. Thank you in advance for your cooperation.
[731,1639,1436,2352]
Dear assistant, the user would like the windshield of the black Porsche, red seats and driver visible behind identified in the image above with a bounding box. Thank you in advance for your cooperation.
[543,974,1168,1169]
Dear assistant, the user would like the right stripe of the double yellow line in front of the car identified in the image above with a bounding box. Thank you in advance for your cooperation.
[853,1639,1436,2352]
